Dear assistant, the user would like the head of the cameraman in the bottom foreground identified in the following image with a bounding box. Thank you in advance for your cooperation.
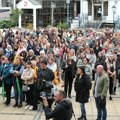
[54,90,66,103]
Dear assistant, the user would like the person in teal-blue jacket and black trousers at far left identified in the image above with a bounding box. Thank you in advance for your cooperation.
[0,57,12,106]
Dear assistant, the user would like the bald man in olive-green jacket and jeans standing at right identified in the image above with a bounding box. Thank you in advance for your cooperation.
[93,65,109,120]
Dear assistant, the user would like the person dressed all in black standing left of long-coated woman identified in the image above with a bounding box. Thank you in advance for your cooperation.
[62,55,76,98]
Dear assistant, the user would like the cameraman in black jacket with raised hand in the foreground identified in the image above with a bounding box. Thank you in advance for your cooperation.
[42,90,73,120]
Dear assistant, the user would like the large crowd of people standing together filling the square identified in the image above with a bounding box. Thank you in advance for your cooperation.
[0,27,120,120]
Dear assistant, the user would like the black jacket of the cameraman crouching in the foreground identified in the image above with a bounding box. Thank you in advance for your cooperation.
[44,99,73,120]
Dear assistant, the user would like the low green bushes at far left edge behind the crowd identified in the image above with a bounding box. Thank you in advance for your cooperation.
[0,20,16,29]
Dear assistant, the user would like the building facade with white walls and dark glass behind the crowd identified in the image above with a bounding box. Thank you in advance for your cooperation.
[0,0,120,27]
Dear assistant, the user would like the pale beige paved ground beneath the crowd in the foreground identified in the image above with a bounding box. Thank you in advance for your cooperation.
[0,82,120,120]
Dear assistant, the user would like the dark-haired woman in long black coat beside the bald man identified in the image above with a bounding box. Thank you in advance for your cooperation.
[74,66,92,120]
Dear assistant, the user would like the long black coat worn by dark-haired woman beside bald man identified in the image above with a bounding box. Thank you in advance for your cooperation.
[74,74,92,103]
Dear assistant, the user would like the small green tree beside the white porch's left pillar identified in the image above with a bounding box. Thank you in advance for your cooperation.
[11,8,23,26]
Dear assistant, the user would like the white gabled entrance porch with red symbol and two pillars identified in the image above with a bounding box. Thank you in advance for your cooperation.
[17,0,42,29]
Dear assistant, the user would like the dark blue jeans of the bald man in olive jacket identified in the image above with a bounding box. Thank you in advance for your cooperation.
[95,97,107,120]
